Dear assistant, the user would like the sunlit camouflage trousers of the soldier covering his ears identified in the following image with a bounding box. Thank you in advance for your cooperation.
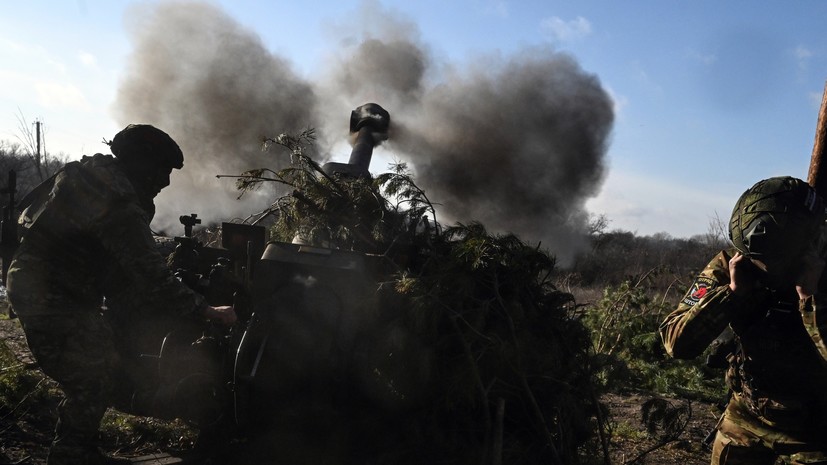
[711,394,827,465]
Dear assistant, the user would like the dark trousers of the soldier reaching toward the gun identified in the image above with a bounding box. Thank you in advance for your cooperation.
[18,309,117,465]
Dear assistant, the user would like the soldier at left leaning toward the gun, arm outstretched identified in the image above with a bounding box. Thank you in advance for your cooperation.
[8,125,236,465]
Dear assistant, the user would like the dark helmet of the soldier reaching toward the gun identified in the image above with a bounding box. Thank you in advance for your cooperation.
[109,124,184,169]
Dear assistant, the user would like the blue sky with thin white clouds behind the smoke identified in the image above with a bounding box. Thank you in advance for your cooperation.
[0,0,827,246]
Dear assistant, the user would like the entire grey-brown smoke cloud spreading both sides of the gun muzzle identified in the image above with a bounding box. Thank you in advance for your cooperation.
[116,2,614,262]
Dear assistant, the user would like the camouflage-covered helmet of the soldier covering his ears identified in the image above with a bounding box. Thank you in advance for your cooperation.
[729,176,825,273]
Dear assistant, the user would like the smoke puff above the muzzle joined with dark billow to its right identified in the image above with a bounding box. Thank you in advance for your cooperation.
[319,2,614,262]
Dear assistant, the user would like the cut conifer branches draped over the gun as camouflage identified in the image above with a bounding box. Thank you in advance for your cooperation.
[230,128,602,464]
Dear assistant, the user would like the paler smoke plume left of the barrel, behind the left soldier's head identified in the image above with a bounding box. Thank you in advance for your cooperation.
[115,2,316,234]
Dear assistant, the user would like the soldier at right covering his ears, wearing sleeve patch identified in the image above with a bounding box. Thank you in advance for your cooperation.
[660,177,827,465]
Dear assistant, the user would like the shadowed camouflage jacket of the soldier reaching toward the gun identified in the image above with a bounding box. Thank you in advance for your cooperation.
[8,154,206,317]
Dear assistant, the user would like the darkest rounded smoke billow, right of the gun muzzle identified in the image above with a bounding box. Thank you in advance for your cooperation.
[398,50,613,260]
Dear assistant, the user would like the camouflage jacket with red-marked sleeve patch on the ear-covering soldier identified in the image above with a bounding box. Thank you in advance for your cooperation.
[660,249,827,403]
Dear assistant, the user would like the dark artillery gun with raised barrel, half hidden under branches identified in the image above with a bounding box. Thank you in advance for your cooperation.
[114,103,427,464]
